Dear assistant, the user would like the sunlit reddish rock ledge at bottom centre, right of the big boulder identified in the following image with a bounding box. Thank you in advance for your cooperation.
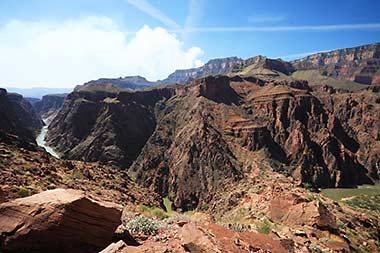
[101,222,291,253]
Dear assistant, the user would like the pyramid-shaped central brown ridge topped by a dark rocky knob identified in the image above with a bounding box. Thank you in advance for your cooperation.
[129,77,241,210]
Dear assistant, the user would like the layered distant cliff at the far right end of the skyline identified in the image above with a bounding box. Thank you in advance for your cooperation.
[292,43,380,85]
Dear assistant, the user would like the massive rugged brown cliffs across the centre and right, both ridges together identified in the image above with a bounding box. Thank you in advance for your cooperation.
[129,77,378,210]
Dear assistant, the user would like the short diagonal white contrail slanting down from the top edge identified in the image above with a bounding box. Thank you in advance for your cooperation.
[126,0,181,29]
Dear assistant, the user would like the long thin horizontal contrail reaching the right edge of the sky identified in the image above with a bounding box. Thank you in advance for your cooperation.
[172,23,380,33]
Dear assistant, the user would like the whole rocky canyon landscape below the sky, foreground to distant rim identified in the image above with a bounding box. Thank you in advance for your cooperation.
[0,43,380,252]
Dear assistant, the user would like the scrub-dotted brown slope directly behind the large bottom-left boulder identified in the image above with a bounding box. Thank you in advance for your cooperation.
[0,135,161,206]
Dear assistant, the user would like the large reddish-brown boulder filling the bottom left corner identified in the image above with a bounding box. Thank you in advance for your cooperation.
[0,189,121,253]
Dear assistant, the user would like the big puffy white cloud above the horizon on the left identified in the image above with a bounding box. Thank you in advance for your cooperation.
[0,17,203,87]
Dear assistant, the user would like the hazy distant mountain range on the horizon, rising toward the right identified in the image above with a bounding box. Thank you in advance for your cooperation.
[76,43,380,92]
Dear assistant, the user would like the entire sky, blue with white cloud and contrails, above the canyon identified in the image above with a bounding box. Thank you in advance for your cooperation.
[0,0,380,87]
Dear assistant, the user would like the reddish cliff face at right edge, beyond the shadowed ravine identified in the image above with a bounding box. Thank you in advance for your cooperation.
[320,87,380,180]
